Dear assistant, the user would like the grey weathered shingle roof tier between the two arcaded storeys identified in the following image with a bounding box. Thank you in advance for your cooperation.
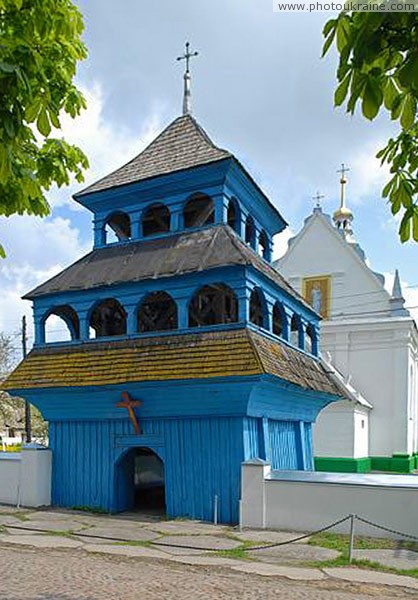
[24,225,312,310]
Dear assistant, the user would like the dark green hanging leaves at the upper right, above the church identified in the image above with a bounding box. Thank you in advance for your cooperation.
[323,12,418,242]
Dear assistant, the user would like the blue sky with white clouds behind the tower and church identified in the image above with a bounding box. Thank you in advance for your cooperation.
[0,0,418,352]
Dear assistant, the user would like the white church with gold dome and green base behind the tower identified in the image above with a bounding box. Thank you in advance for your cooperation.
[276,169,418,473]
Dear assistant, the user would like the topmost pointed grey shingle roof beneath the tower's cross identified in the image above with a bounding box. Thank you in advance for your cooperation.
[75,115,232,197]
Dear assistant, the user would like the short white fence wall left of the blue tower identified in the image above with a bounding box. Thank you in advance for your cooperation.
[0,444,51,507]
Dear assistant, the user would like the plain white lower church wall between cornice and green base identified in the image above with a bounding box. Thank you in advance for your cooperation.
[321,319,415,456]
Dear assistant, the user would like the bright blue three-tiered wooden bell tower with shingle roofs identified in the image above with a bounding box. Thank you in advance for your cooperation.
[6,104,342,523]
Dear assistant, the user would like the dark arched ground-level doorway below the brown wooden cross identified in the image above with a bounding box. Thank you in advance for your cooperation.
[116,447,165,514]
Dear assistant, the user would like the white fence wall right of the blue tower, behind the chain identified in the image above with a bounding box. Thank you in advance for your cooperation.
[241,461,418,538]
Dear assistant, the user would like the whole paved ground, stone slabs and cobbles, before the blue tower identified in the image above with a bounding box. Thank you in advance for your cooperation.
[0,506,418,600]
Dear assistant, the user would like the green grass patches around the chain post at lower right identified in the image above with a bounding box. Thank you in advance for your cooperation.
[305,532,418,579]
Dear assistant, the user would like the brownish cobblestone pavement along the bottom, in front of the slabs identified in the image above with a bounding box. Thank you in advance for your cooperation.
[0,546,416,600]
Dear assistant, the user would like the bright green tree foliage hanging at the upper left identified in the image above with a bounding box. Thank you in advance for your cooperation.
[0,0,88,257]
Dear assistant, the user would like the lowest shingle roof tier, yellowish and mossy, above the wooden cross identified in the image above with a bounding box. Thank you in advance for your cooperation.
[3,329,344,396]
